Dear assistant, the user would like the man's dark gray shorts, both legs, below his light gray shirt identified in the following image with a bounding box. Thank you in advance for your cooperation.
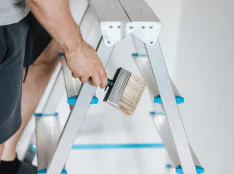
[0,13,51,144]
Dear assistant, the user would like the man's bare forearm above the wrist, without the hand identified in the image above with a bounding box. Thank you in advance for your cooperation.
[26,0,82,52]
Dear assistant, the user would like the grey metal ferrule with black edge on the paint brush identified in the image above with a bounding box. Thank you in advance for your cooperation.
[104,68,131,106]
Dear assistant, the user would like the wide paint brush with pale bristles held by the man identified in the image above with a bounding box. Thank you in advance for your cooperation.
[104,68,146,116]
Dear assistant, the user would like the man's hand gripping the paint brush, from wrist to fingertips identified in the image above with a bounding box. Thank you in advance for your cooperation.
[65,41,107,88]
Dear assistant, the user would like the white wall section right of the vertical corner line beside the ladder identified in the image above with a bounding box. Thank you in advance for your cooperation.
[176,0,234,174]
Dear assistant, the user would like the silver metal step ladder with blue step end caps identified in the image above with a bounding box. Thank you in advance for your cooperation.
[24,0,204,174]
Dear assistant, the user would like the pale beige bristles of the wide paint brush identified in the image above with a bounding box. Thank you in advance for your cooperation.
[112,75,146,116]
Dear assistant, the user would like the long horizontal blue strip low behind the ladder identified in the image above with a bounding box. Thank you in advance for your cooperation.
[30,143,165,151]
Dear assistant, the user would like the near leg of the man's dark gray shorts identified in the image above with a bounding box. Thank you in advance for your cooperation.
[0,17,29,144]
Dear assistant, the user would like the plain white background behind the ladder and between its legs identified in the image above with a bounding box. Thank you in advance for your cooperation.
[18,0,234,174]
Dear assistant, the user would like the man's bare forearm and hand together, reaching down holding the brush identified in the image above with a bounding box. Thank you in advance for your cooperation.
[26,0,107,88]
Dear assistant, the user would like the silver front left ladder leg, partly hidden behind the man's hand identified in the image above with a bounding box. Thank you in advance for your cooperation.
[47,40,113,174]
